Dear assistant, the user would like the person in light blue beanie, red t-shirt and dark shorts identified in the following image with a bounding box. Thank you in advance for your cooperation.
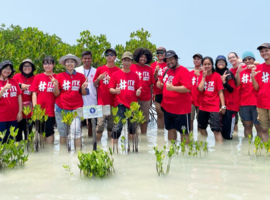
[236,51,262,137]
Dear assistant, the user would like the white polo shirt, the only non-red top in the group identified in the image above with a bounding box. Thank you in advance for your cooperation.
[75,65,97,106]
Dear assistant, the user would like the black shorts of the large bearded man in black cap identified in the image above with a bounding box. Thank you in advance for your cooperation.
[161,107,190,134]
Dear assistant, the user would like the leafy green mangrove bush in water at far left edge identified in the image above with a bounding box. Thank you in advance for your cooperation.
[0,127,28,171]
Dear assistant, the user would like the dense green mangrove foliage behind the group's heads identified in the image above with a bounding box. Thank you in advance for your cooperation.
[0,24,156,73]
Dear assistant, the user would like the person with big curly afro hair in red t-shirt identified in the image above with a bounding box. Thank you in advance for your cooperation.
[130,48,155,134]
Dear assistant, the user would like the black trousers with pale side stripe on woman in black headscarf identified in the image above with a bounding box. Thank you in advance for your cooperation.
[221,110,237,140]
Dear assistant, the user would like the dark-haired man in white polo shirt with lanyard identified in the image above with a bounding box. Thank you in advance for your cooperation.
[75,51,97,136]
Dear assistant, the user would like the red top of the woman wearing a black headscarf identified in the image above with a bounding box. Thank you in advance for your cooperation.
[224,79,239,112]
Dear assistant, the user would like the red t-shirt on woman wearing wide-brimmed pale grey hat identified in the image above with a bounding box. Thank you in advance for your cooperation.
[55,71,86,110]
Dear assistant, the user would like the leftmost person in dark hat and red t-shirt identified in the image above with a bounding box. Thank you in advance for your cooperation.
[0,60,22,143]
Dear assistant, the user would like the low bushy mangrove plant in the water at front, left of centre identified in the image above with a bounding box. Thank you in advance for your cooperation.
[78,147,115,178]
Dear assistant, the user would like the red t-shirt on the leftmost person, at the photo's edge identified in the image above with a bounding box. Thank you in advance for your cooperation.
[0,78,22,122]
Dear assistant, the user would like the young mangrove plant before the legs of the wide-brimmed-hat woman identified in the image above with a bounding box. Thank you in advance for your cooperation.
[61,110,78,151]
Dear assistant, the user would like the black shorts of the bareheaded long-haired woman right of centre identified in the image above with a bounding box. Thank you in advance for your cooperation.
[198,110,221,132]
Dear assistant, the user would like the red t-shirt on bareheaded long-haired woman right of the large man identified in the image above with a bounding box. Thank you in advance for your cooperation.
[199,72,224,112]
